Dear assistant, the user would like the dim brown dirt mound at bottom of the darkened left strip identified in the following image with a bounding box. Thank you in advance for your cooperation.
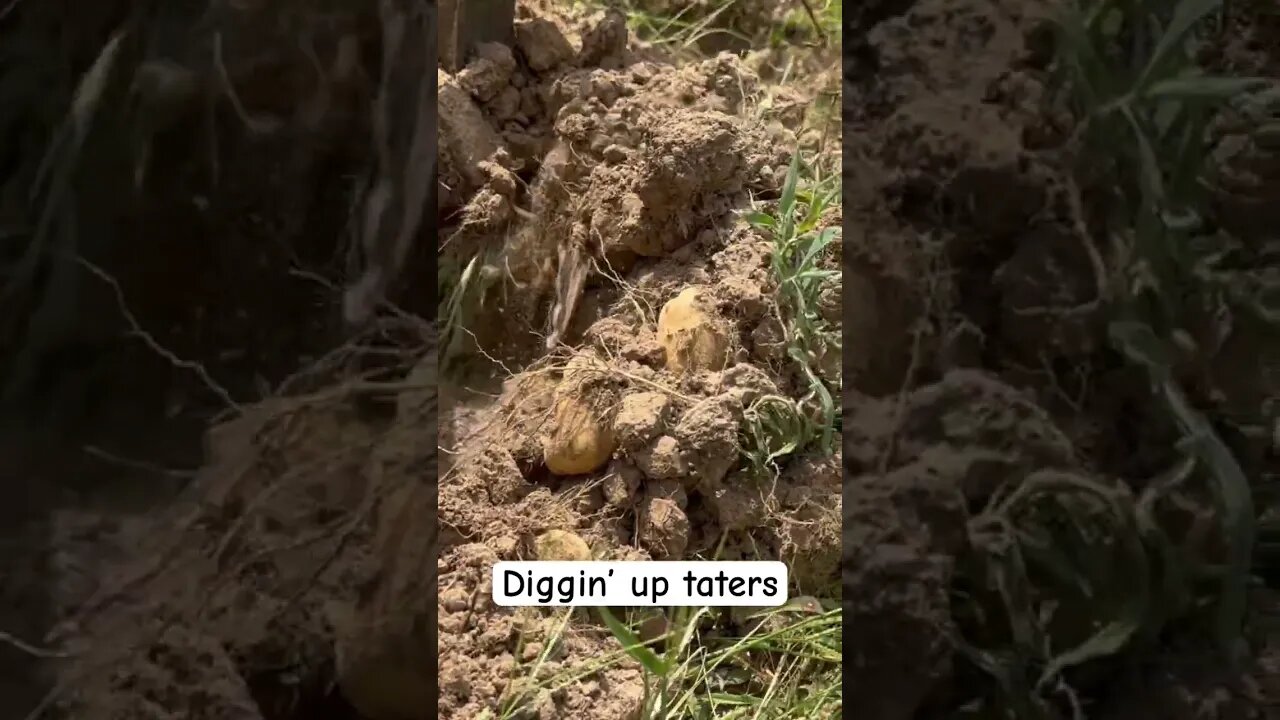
[31,338,435,719]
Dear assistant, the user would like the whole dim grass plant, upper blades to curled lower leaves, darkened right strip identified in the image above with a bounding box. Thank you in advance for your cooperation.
[957,0,1274,719]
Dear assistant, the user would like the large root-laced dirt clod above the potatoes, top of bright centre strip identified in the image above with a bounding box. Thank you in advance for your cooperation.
[440,7,794,358]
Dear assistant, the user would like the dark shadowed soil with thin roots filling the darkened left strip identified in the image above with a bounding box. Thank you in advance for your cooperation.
[0,1,436,720]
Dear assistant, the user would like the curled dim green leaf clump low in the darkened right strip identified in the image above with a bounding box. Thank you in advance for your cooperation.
[957,471,1158,719]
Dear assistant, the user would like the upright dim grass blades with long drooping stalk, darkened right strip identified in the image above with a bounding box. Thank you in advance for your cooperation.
[1062,0,1271,657]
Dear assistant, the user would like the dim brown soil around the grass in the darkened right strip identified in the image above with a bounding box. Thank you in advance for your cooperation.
[842,0,1280,720]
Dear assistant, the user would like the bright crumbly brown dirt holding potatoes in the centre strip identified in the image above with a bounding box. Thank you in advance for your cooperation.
[439,8,840,719]
